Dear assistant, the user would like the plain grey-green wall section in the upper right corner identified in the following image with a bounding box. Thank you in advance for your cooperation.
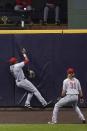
[68,0,87,28]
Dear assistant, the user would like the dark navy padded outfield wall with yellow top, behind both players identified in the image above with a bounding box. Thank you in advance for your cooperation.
[0,30,87,107]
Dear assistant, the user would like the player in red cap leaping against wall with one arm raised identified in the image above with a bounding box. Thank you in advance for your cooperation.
[9,49,50,108]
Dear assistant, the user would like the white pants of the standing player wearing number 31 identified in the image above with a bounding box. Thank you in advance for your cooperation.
[52,95,85,123]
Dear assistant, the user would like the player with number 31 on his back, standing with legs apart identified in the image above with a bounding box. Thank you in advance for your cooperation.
[48,68,86,124]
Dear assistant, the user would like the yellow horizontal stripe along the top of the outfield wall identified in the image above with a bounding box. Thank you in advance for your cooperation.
[0,29,87,34]
